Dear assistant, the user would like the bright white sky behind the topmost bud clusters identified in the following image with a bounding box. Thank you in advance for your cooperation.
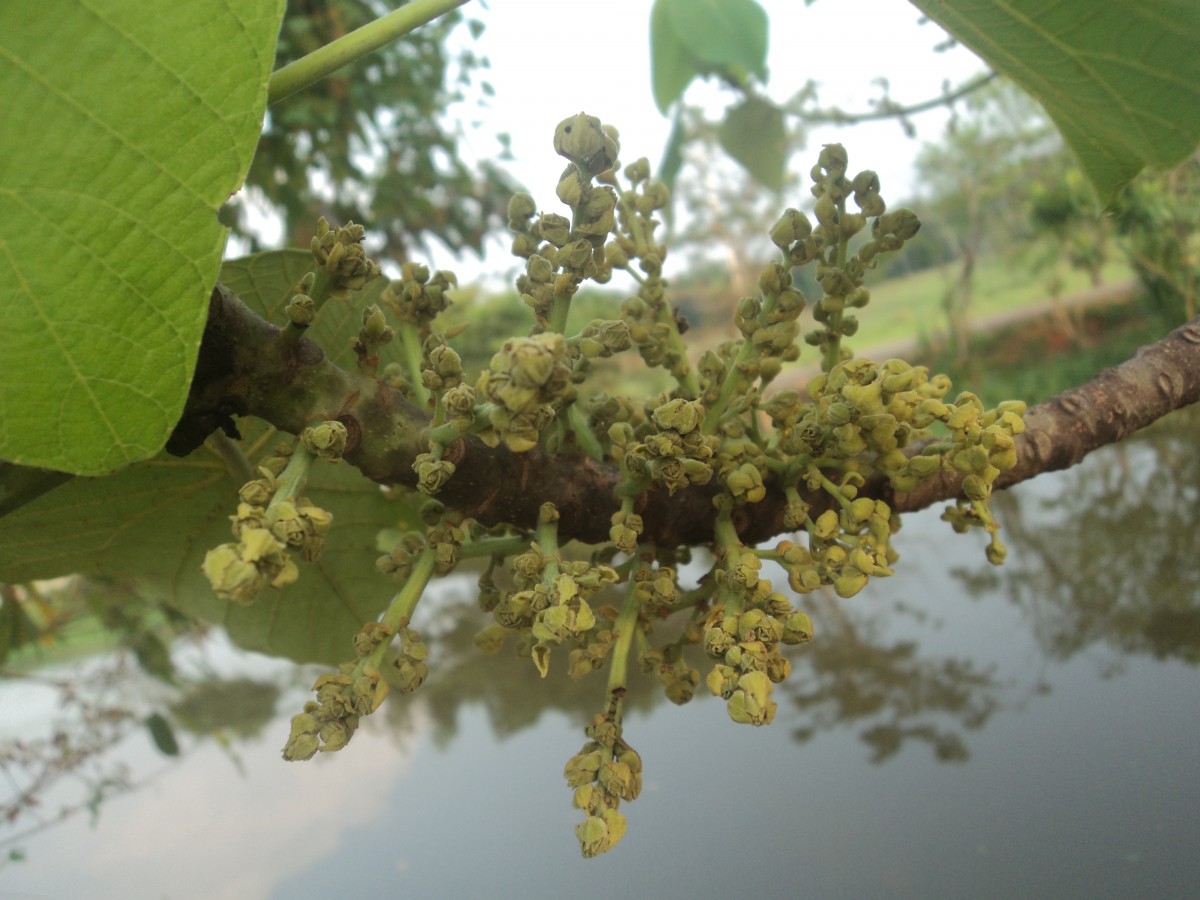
[433,0,985,280]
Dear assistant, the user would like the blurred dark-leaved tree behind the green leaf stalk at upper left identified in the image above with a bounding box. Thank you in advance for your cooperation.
[226,0,515,262]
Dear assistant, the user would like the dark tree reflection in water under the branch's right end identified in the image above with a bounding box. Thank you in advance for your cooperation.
[956,409,1200,668]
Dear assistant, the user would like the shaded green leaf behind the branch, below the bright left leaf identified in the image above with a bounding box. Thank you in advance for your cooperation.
[0,251,422,662]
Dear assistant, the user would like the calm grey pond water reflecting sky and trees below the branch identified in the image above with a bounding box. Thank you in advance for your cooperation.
[0,416,1200,900]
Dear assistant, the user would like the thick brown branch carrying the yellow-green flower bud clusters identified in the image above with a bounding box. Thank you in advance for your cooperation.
[167,284,1200,547]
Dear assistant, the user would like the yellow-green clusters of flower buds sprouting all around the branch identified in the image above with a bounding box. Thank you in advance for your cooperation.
[204,113,1025,857]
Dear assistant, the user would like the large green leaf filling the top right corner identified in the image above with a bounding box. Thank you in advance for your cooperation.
[913,0,1200,204]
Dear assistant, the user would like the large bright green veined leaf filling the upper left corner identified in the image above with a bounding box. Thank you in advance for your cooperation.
[0,0,283,474]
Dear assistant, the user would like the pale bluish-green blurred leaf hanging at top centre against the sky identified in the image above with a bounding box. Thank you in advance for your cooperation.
[650,0,767,114]
